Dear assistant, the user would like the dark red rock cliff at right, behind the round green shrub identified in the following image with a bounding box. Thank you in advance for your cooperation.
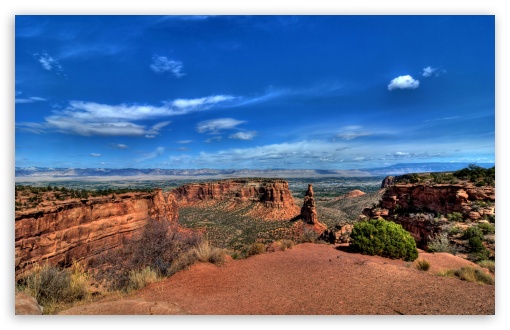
[363,177,496,243]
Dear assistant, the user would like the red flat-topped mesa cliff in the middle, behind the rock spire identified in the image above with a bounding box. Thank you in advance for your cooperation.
[171,179,299,220]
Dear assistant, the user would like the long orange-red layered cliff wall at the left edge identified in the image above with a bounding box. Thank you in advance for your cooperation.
[15,190,178,276]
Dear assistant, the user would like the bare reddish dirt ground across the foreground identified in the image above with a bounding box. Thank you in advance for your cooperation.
[61,244,495,315]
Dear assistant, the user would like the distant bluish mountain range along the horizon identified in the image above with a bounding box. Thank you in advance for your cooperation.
[15,163,495,179]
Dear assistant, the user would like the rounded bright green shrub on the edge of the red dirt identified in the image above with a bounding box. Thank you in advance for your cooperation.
[350,219,418,261]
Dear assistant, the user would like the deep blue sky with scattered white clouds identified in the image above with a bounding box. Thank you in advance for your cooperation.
[14,15,495,169]
